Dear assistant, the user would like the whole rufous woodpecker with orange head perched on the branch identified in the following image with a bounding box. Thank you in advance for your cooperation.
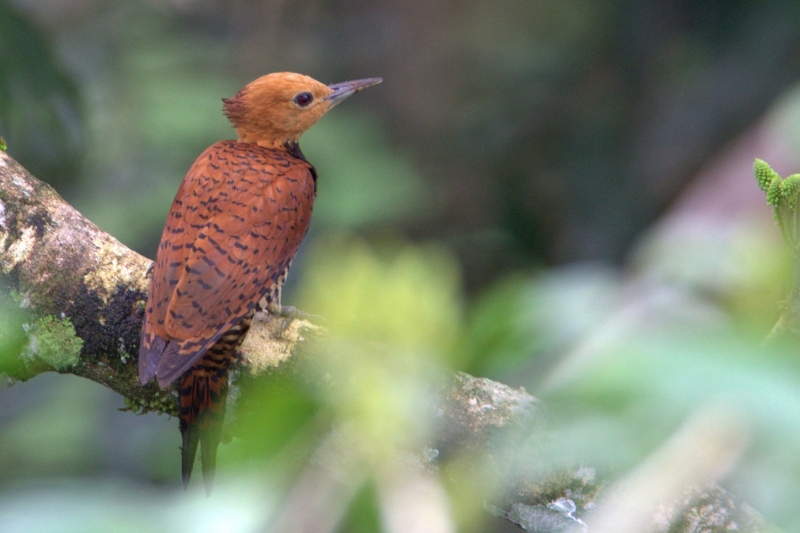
[139,72,383,493]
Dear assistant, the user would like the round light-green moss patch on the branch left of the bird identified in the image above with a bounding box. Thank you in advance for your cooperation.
[23,316,83,370]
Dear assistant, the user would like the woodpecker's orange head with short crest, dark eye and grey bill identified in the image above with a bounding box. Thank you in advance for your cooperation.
[222,72,383,148]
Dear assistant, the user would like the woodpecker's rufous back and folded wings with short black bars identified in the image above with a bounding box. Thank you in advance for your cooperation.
[139,141,315,386]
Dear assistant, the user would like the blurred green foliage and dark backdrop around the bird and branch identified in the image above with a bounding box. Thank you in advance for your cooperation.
[0,0,800,532]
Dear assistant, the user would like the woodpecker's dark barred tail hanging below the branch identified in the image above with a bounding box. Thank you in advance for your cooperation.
[179,360,228,494]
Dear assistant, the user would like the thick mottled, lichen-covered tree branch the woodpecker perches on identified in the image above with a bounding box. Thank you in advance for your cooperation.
[0,151,772,532]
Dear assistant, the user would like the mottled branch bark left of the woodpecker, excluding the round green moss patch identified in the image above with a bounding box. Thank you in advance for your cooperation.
[0,153,159,403]
